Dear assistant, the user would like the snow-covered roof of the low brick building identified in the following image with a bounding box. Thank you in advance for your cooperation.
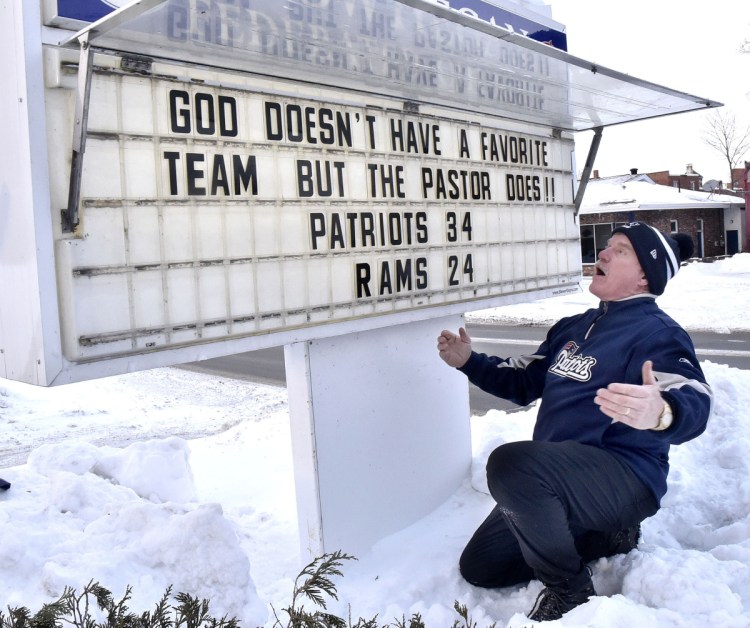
[580,175,745,214]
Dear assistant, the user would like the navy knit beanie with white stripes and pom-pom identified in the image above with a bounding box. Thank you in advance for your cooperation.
[612,222,693,295]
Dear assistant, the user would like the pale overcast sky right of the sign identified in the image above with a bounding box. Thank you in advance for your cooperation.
[545,0,750,182]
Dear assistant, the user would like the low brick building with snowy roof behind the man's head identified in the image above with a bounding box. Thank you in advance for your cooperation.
[578,171,745,274]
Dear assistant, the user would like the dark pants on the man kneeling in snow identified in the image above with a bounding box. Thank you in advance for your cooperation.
[460,441,659,587]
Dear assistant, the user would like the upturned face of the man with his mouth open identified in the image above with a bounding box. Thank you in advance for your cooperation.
[589,233,648,301]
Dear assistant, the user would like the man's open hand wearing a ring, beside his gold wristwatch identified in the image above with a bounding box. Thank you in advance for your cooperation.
[594,360,664,430]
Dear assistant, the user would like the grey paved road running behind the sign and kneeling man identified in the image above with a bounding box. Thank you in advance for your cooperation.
[183,324,750,415]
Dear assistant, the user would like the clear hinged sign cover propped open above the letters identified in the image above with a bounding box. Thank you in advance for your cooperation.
[60,0,721,131]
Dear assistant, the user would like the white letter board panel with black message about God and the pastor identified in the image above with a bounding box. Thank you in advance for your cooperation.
[57,65,580,362]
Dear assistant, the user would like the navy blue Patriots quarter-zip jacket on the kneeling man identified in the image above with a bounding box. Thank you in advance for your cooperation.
[459,295,713,501]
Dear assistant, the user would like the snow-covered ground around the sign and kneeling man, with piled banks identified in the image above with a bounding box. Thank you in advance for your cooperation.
[0,254,750,628]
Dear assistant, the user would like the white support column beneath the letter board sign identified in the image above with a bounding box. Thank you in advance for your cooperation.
[285,316,471,561]
